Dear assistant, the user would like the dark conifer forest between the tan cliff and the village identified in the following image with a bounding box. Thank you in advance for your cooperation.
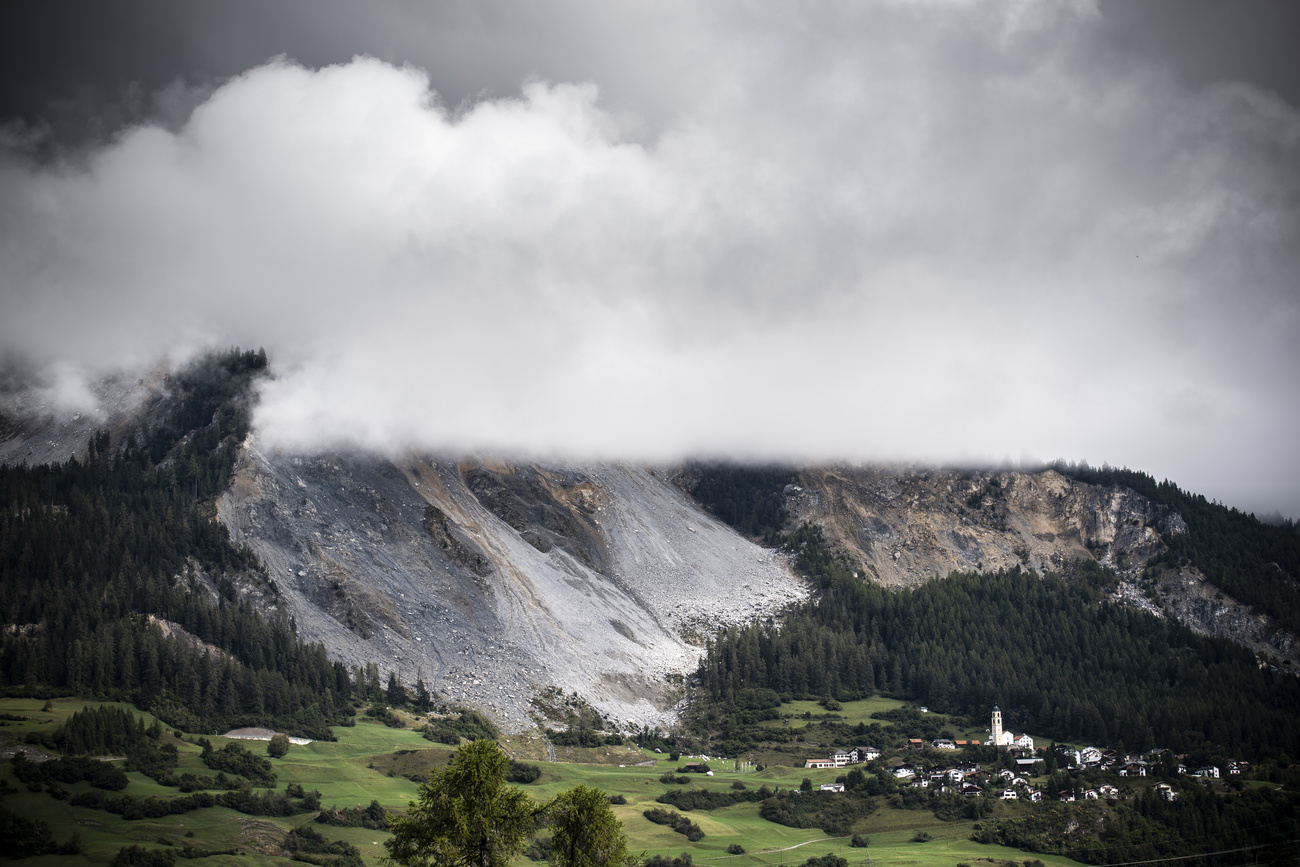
[697,525,1300,759]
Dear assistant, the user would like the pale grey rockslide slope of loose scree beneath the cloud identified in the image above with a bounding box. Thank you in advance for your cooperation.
[218,447,807,731]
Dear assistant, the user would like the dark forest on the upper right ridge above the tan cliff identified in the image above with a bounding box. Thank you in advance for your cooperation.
[1053,461,1300,633]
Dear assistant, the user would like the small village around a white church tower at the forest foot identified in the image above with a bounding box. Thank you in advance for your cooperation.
[803,707,1251,802]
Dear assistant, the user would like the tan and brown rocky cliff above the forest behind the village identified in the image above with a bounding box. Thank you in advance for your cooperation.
[785,467,1300,671]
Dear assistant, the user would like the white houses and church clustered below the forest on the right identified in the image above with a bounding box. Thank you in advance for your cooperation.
[803,707,1249,802]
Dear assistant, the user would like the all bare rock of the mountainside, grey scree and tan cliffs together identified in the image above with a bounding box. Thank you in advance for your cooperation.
[0,356,1300,728]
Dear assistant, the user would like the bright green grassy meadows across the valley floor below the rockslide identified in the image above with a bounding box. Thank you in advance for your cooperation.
[0,699,1067,867]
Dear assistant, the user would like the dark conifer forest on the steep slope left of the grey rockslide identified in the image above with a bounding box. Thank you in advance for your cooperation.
[0,351,352,738]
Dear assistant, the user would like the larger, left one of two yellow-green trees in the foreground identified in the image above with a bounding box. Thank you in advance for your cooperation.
[384,741,542,867]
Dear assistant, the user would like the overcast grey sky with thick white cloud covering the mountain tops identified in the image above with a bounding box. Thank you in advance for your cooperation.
[0,0,1300,516]
